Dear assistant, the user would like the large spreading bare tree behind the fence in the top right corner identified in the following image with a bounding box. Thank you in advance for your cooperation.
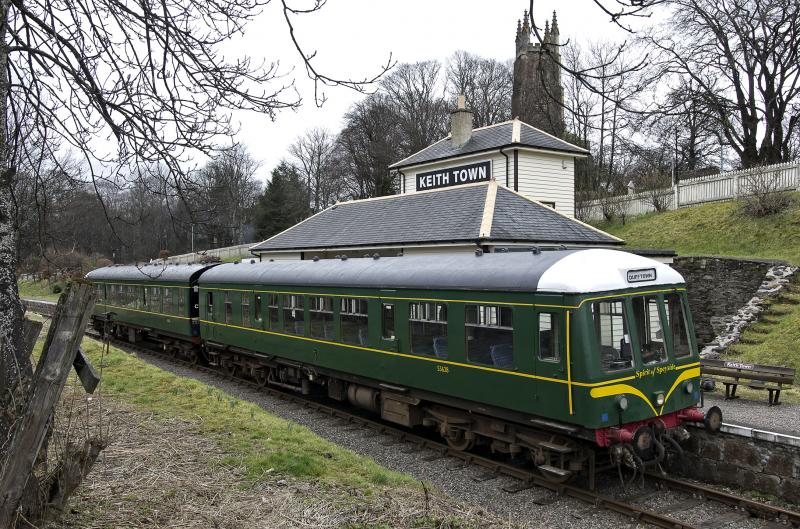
[642,0,800,167]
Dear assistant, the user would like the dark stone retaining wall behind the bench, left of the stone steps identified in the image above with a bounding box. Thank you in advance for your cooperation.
[672,257,776,344]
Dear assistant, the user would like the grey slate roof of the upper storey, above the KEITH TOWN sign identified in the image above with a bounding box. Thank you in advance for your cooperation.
[389,120,588,169]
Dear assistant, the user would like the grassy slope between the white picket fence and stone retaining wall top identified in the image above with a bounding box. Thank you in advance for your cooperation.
[596,193,800,265]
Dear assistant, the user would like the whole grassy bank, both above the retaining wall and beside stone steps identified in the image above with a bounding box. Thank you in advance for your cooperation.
[597,193,800,401]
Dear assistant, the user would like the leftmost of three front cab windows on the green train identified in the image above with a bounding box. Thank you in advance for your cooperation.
[592,299,633,372]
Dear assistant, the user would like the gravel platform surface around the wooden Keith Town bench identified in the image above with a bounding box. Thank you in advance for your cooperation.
[704,390,800,436]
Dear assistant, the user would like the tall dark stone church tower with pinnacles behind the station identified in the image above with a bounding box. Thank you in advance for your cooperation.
[511,11,564,138]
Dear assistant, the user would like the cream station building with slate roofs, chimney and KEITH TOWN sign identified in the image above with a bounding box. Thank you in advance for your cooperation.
[250,98,648,260]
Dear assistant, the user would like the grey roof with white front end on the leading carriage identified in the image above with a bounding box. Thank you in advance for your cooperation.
[199,248,684,294]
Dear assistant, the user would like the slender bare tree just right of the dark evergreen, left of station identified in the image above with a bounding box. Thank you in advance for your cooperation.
[289,128,342,213]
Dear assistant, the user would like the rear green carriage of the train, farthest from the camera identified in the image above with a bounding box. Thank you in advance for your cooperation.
[86,265,216,343]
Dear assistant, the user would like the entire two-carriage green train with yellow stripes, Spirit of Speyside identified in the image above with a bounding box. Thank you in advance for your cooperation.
[87,249,722,481]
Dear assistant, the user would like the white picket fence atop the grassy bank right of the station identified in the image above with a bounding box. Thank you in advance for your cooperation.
[577,161,800,221]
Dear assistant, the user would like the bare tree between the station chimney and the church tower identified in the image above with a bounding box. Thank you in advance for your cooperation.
[445,51,513,127]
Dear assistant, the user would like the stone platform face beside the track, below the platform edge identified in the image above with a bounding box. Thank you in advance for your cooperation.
[673,428,800,503]
